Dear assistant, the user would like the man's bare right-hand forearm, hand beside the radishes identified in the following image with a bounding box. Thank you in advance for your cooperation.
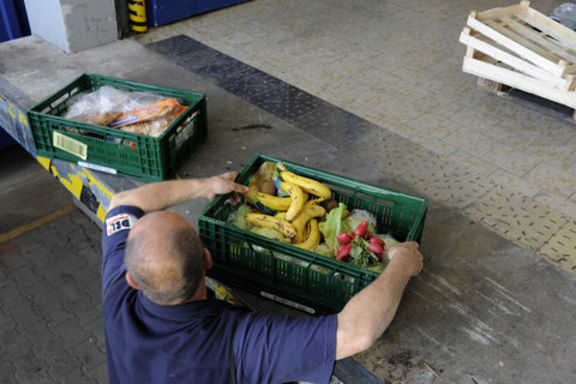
[336,242,422,360]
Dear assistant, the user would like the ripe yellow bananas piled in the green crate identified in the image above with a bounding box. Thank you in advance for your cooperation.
[246,170,332,250]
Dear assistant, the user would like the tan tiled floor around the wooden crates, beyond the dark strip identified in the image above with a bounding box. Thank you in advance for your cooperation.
[138,0,576,273]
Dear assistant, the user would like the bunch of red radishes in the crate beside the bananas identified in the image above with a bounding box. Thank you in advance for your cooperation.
[336,220,386,262]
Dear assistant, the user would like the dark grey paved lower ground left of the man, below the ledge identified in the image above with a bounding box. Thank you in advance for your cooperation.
[0,147,107,384]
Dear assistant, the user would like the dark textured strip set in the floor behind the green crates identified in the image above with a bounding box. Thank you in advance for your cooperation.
[147,35,378,145]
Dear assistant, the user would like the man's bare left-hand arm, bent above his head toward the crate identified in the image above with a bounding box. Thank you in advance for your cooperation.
[109,172,248,213]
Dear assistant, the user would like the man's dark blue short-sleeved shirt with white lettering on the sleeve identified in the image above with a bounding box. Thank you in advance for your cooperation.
[102,206,337,384]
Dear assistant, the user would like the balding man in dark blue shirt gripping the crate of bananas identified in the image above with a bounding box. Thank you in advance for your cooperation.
[102,172,422,384]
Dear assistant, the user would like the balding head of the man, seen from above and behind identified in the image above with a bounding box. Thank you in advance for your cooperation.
[124,211,205,305]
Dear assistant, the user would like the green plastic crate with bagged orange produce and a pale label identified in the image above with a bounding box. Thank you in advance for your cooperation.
[27,73,207,181]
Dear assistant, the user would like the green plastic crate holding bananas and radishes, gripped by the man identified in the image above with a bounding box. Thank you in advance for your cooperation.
[198,155,428,313]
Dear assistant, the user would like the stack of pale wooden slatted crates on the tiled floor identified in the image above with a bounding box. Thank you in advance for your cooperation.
[460,0,576,115]
